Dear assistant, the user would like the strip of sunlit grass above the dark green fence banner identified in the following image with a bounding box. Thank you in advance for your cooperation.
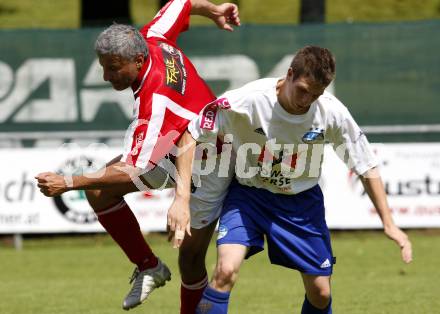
[0,0,440,28]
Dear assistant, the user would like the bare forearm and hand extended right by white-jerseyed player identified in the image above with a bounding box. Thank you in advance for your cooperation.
[361,168,412,263]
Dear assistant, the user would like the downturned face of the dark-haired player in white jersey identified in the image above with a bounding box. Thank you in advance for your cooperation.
[286,69,327,114]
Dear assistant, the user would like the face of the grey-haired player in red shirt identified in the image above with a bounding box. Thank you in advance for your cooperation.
[99,55,139,90]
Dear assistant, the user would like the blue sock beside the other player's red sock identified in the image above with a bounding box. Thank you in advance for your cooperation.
[196,285,230,314]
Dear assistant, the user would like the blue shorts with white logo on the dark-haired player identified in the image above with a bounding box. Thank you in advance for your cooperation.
[217,181,335,276]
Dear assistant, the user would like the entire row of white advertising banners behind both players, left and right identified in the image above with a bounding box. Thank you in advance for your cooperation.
[0,143,440,234]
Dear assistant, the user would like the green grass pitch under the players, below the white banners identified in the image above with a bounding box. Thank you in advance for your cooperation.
[0,231,440,314]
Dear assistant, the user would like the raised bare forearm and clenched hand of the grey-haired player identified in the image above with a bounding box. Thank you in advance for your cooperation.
[191,0,240,32]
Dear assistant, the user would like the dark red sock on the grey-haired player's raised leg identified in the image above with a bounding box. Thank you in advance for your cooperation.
[98,200,158,271]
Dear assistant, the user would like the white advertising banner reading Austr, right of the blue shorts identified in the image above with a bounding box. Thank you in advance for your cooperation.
[321,143,440,229]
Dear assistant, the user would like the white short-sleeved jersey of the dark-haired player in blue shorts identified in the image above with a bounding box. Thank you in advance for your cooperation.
[188,78,377,194]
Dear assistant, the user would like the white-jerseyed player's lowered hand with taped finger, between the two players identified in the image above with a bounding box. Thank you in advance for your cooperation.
[167,197,191,248]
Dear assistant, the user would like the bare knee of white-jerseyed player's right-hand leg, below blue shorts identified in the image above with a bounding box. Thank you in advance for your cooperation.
[301,274,331,314]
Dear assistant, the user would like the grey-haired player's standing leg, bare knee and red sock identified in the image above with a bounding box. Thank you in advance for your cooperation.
[179,220,217,314]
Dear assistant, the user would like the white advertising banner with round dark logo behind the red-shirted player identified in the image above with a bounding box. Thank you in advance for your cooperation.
[0,145,174,233]
